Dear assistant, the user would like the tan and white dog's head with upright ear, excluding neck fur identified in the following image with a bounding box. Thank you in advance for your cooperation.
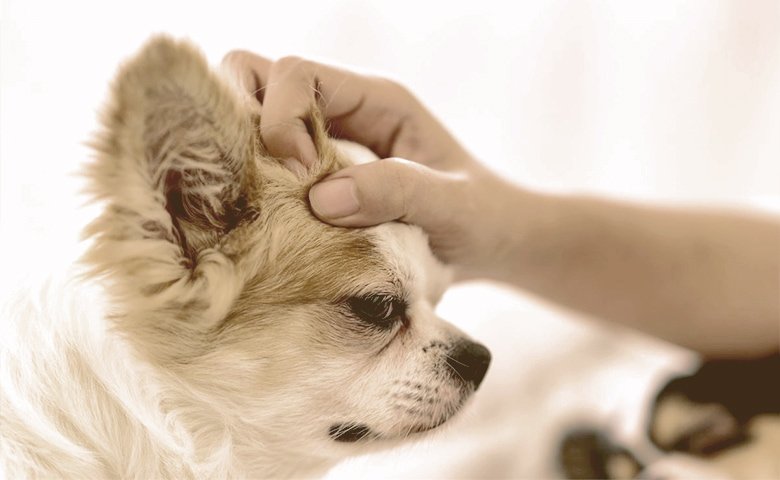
[86,38,490,468]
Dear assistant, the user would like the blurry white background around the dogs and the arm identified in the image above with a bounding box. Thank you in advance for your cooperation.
[0,0,780,478]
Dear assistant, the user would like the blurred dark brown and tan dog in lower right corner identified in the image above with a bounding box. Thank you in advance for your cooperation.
[560,354,780,479]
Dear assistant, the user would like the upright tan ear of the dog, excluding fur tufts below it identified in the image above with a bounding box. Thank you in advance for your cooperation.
[92,37,254,255]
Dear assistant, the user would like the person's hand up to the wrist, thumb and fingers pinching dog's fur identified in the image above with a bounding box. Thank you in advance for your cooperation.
[223,51,524,278]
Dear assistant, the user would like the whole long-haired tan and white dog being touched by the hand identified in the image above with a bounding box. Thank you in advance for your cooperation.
[0,36,490,479]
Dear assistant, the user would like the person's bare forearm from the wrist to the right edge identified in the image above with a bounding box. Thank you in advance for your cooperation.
[492,189,780,356]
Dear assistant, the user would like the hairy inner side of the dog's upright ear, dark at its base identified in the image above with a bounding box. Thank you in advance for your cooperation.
[117,41,255,259]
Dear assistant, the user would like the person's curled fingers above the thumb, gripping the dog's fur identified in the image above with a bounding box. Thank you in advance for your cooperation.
[223,51,413,166]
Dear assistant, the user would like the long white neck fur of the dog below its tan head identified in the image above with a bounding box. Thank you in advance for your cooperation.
[0,280,334,478]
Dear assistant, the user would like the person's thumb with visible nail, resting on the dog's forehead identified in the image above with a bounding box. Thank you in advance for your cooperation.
[309,158,458,230]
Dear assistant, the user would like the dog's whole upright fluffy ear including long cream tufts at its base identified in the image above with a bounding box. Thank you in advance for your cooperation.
[86,37,259,330]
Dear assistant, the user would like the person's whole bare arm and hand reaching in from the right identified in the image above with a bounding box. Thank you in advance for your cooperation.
[219,51,780,358]
